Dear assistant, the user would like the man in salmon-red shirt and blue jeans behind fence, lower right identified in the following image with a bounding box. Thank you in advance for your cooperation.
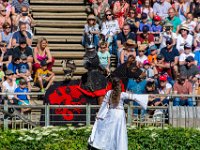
[173,75,193,106]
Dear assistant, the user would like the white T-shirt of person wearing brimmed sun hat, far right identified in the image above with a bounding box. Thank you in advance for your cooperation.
[176,34,193,51]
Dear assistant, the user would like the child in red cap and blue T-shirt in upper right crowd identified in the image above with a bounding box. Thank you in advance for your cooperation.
[152,15,162,43]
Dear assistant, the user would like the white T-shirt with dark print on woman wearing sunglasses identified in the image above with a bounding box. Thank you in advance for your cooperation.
[101,20,120,36]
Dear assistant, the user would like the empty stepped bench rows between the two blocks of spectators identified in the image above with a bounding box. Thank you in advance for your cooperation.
[30,0,87,81]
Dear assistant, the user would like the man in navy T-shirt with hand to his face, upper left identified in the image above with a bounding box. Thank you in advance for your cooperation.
[11,22,32,47]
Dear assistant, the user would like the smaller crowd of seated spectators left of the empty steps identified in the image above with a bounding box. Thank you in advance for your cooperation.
[0,0,55,112]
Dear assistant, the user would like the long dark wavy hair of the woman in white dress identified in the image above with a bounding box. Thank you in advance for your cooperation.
[110,77,122,105]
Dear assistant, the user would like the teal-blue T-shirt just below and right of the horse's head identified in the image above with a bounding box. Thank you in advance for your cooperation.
[127,79,147,94]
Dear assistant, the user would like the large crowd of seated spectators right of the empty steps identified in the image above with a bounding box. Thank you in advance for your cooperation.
[83,0,200,115]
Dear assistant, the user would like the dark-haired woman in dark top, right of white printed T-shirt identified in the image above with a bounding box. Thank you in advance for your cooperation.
[126,8,140,33]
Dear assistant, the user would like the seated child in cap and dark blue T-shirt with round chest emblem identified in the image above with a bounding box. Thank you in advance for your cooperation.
[16,54,33,82]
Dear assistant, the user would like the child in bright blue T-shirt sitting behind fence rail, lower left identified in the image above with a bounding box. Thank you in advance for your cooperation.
[14,79,30,113]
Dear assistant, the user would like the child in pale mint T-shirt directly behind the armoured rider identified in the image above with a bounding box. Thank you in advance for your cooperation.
[97,42,111,74]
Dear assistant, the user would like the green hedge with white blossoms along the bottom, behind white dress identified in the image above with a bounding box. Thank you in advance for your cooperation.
[0,126,200,150]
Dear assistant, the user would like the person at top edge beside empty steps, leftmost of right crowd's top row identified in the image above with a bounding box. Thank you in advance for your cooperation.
[92,0,110,26]
